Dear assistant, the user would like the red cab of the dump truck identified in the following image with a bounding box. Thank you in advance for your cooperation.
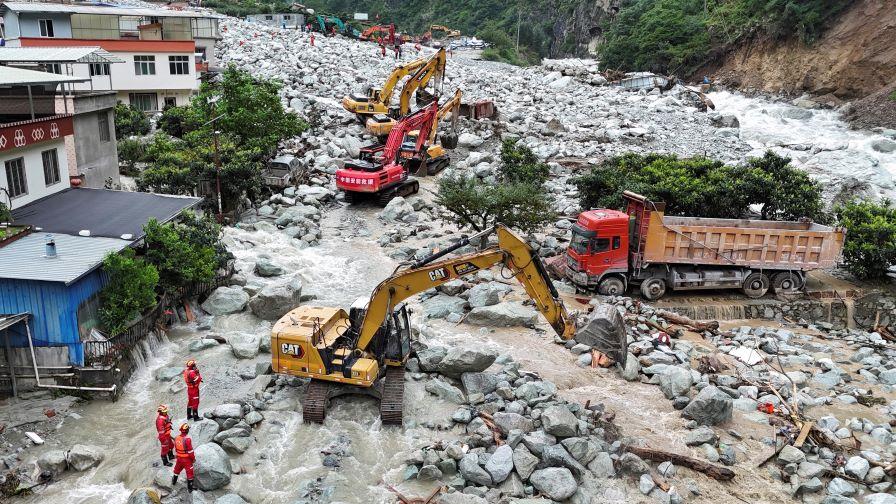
[566,209,630,295]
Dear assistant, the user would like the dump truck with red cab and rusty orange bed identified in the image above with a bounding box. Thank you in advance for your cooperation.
[565,191,846,300]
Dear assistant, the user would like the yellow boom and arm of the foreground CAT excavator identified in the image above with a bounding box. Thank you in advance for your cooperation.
[356,225,576,350]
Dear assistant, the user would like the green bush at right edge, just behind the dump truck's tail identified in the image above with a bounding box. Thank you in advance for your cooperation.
[834,200,896,280]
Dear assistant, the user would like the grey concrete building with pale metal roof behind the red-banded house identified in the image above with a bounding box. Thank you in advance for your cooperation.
[0,46,124,188]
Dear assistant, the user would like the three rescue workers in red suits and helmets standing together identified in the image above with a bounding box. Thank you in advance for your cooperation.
[156,359,202,492]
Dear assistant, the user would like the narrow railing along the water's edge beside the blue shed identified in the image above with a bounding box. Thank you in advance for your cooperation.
[84,261,234,367]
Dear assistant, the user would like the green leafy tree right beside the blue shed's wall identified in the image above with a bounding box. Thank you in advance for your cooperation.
[99,248,159,336]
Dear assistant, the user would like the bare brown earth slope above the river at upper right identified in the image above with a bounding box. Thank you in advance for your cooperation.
[705,0,896,99]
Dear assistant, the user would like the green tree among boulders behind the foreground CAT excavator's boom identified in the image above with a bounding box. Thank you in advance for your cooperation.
[436,142,556,232]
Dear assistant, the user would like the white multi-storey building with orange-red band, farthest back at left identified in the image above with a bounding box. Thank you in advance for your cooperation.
[0,2,220,112]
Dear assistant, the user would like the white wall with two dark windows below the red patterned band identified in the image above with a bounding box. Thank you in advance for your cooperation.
[0,138,70,208]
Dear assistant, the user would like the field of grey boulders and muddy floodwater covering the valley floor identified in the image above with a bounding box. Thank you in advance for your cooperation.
[0,4,896,504]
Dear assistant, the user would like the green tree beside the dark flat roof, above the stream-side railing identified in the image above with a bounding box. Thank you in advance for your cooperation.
[143,219,219,293]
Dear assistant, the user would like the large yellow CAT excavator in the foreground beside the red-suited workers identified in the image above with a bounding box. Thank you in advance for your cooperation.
[271,225,626,425]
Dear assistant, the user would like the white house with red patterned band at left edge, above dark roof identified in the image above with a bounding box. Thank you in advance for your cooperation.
[0,67,83,209]
